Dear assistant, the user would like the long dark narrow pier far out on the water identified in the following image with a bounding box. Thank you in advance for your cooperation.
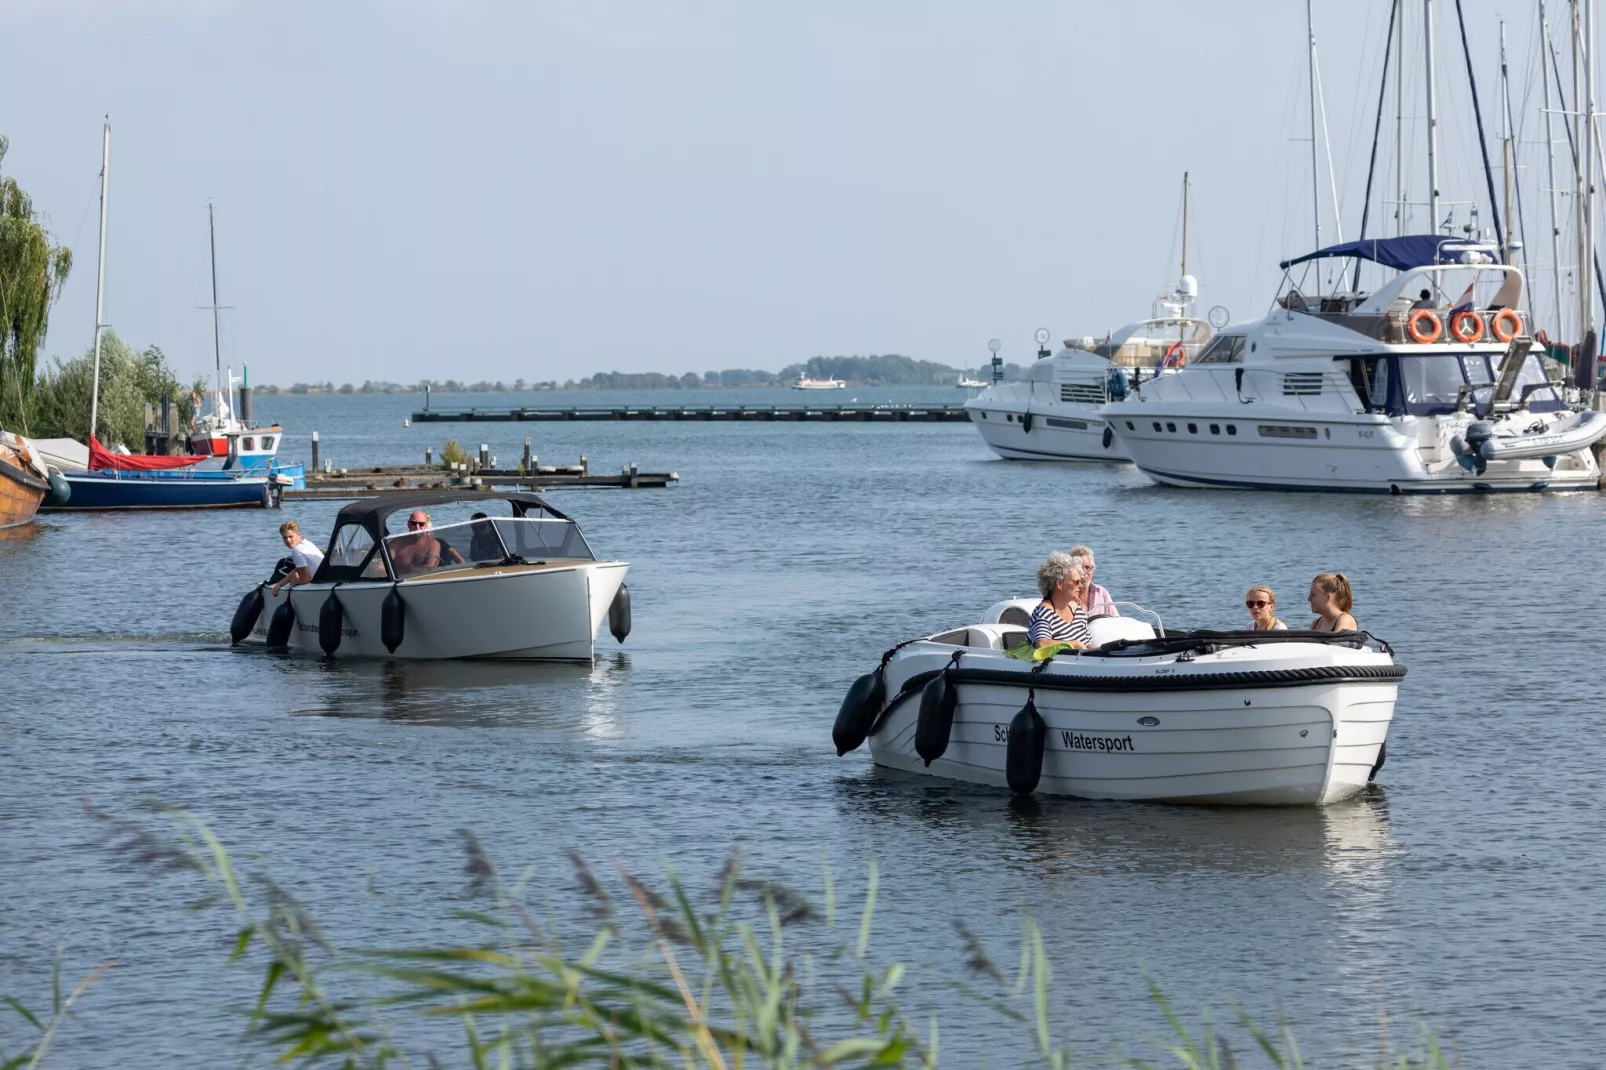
[413,403,970,424]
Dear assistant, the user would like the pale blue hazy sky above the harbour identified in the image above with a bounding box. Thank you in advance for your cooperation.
[0,0,1566,386]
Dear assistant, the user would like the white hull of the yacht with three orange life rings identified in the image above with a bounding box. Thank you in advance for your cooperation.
[1103,404,1600,493]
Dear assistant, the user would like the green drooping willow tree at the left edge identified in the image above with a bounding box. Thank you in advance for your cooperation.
[0,137,72,427]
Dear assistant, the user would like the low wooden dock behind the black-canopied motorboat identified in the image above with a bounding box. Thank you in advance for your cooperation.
[284,458,681,501]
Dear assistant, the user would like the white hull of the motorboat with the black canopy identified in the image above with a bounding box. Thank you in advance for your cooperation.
[244,561,630,662]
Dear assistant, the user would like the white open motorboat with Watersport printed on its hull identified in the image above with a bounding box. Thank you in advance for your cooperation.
[832,599,1405,805]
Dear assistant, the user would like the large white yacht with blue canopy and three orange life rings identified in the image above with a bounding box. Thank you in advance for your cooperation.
[1100,235,1606,493]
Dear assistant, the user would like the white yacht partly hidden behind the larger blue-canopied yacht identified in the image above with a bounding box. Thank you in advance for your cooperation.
[965,275,1213,461]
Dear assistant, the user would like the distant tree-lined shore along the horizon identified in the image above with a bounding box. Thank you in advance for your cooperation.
[252,353,1025,395]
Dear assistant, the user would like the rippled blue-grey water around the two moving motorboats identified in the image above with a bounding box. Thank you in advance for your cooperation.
[0,390,1606,1067]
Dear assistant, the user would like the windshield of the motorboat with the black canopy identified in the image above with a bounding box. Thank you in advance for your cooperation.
[385,516,596,577]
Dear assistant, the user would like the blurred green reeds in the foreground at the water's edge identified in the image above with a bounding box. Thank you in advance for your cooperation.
[0,802,1458,1070]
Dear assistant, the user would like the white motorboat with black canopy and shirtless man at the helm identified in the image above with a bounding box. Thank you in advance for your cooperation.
[230,490,630,662]
